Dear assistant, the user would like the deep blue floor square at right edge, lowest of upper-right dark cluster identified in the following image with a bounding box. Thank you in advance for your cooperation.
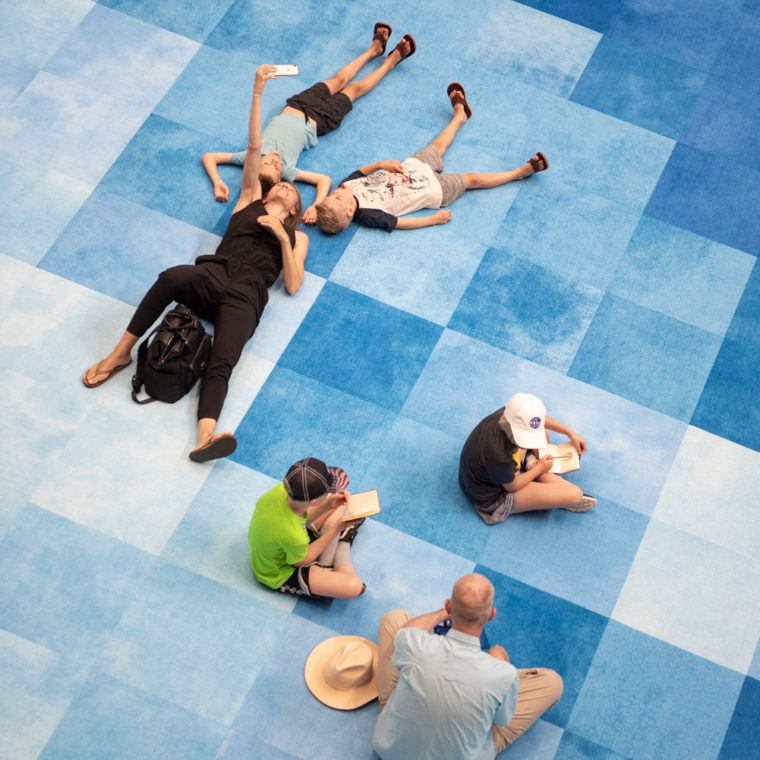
[645,144,760,256]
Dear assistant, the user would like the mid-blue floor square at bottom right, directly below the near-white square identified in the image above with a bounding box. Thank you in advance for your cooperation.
[568,621,743,760]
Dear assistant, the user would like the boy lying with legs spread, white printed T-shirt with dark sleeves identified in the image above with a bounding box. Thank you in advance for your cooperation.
[314,82,549,235]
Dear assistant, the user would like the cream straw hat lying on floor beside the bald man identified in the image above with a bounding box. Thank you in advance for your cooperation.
[304,636,378,710]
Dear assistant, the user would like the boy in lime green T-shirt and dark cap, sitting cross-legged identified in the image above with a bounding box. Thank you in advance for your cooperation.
[248,457,366,599]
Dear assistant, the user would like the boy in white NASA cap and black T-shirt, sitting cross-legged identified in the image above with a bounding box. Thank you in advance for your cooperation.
[459,393,596,525]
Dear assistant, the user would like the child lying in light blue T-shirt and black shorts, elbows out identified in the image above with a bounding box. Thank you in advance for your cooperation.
[201,21,416,223]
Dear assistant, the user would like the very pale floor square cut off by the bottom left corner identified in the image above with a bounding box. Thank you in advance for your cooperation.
[0,631,86,758]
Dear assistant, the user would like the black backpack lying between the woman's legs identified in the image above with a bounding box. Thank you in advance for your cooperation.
[132,304,211,404]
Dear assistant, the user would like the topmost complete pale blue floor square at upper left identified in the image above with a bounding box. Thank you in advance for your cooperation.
[45,5,198,108]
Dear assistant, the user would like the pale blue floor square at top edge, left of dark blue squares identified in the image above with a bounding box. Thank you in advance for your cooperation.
[458,2,600,96]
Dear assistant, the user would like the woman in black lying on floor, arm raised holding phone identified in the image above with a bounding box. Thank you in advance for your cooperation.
[82,65,309,462]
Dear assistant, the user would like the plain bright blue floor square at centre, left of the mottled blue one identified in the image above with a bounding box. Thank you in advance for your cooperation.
[280,282,443,411]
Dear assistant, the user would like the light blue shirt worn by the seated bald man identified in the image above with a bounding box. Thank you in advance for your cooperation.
[372,627,520,760]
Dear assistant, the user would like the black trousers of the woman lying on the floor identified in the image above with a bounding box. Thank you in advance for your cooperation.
[127,263,266,420]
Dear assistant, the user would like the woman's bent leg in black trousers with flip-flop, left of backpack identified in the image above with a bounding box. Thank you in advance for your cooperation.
[82,264,214,388]
